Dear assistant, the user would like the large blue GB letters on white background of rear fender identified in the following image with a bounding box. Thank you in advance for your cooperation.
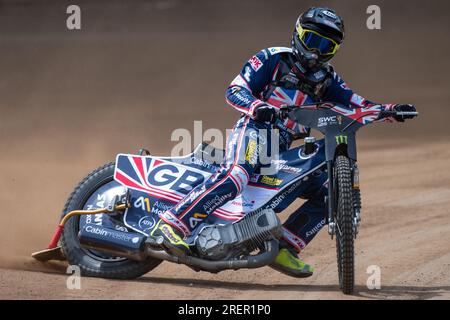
[147,164,209,195]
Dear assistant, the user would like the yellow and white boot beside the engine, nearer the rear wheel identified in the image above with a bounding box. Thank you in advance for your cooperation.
[150,220,190,257]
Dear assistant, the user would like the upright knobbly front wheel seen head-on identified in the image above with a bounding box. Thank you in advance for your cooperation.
[334,156,355,294]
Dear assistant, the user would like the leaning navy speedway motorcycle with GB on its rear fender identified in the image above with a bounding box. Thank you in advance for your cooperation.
[32,103,418,294]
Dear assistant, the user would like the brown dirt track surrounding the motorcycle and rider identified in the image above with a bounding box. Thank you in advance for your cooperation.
[0,0,450,299]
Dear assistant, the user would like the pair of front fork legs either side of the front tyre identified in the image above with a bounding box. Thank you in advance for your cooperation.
[326,161,361,238]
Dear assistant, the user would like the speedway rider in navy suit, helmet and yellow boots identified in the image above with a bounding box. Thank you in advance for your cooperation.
[151,7,415,277]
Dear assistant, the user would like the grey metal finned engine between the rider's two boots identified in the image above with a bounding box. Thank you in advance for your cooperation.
[195,209,281,260]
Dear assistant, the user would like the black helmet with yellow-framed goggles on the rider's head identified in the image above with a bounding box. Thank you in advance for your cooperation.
[292,7,345,69]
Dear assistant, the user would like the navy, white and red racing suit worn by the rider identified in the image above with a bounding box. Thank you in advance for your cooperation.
[161,47,393,251]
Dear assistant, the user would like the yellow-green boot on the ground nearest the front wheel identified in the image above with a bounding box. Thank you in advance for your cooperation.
[270,248,314,278]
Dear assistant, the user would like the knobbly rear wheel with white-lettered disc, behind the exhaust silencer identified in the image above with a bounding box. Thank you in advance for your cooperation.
[61,162,161,279]
